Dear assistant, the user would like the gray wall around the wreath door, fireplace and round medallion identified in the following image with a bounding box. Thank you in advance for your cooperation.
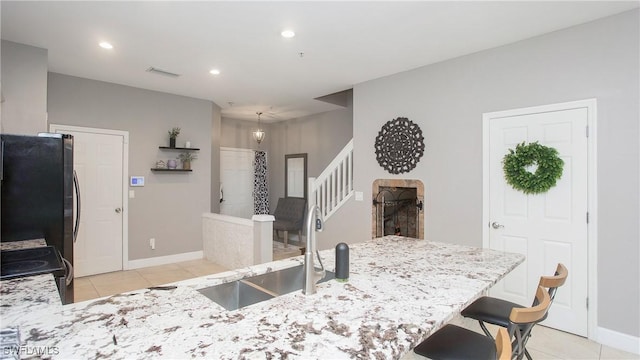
[348,10,640,337]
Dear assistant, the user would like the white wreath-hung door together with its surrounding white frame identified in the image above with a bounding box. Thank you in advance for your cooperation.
[482,99,598,338]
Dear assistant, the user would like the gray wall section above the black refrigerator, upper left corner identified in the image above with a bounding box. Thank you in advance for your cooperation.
[0,40,48,135]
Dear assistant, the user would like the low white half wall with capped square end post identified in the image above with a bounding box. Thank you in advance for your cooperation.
[202,213,275,269]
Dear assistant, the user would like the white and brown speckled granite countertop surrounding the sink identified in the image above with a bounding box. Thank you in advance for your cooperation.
[0,236,524,359]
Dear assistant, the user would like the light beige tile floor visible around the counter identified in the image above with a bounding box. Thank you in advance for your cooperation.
[75,246,640,360]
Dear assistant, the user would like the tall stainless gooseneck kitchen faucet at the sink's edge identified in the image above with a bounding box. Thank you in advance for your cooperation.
[302,205,325,295]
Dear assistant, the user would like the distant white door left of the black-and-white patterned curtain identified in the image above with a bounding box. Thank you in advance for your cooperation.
[220,148,255,219]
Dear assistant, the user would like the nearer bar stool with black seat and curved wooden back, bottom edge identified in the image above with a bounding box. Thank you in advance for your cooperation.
[413,286,551,360]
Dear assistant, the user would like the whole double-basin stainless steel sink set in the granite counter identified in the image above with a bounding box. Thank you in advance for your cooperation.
[198,265,335,310]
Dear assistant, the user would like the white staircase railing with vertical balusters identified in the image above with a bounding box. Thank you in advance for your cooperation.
[308,139,354,221]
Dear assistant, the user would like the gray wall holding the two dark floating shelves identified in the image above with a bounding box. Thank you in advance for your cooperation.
[48,73,220,260]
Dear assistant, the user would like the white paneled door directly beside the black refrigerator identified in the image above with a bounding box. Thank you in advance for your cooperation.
[55,125,125,277]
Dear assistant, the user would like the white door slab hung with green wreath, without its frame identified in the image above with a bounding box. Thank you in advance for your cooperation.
[485,102,589,336]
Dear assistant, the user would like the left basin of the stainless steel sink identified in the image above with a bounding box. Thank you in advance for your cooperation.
[198,280,274,310]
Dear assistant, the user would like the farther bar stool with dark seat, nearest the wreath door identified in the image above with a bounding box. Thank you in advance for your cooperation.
[461,263,569,360]
